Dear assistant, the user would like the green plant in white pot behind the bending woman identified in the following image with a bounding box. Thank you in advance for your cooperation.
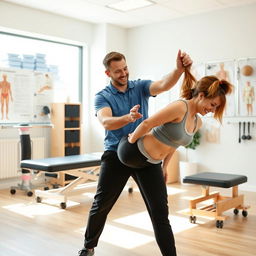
[179,130,201,183]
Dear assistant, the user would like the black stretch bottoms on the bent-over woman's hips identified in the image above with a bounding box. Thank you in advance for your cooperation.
[117,136,153,168]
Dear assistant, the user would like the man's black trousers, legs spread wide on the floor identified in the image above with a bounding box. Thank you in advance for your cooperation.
[84,151,176,256]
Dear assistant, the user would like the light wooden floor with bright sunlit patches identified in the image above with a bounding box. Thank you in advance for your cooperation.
[0,181,256,256]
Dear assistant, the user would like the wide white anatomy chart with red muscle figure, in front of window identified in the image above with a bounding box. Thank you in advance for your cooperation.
[0,68,53,125]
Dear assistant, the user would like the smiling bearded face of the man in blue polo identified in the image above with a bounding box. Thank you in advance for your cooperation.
[105,59,129,87]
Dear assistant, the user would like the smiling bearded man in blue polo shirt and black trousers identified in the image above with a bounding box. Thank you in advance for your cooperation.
[79,50,192,256]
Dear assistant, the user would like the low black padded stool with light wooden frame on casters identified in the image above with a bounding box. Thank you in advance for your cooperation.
[183,172,249,228]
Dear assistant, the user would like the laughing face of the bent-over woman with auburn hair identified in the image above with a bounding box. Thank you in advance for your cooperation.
[197,95,221,116]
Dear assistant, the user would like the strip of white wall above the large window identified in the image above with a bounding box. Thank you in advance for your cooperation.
[0,1,93,44]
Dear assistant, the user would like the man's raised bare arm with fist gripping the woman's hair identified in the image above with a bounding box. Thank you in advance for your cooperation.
[149,50,192,96]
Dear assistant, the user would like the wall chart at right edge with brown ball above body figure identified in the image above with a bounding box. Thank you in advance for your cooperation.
[238,58,256,116]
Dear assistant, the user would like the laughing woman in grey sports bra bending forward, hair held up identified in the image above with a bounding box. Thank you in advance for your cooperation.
[117,70,233,178]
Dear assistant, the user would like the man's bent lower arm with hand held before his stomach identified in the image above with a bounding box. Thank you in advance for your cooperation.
[97,105,142,130]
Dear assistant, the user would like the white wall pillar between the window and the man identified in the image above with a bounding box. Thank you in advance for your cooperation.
[87,24,127,152]
